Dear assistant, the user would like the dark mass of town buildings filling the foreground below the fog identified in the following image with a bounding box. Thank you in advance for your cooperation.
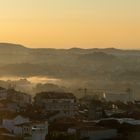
[0,87,140,140]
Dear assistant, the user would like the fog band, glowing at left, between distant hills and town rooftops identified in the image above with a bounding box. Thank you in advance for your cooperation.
[0,76,140,98]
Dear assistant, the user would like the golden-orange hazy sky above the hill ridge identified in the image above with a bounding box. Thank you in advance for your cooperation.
[0,0,140,48]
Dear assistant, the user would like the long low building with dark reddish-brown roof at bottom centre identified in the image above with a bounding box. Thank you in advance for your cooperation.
[48,118,118,140]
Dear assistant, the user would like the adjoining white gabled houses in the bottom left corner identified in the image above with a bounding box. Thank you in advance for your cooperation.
[2,115,48,140]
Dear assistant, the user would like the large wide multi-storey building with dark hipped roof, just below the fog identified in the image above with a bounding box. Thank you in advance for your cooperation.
[34,92,76,116]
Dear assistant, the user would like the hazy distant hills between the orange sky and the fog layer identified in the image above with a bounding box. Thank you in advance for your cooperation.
[0,43,140,98]
